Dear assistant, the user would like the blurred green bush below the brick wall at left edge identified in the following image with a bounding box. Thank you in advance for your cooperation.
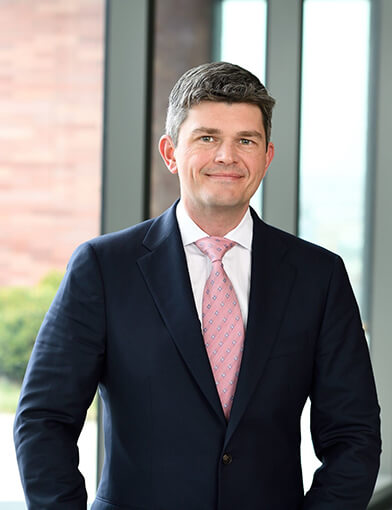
[0,271,62,382]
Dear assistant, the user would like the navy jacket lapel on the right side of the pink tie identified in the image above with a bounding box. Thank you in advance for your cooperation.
[225,214,295,445]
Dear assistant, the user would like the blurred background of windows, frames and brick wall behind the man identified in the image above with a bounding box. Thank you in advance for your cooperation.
[0,0,392,510]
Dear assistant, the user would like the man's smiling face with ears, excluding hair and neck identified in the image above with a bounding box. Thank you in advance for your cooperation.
[160,101,274,221]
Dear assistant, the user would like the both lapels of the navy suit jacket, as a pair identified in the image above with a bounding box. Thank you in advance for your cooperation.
[138,205,295,436]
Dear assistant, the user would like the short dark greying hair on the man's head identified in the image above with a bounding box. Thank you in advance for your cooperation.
[166,62,275,146]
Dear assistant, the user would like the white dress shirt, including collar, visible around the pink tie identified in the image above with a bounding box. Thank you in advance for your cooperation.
[176,200,253,328]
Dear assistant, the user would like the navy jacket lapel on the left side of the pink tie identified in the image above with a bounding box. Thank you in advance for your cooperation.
[138,205,225,423]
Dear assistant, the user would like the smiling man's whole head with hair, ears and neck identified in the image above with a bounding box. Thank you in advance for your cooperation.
[159,63,274,235]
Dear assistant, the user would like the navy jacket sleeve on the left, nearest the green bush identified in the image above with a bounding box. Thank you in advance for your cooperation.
[14,243,105,510]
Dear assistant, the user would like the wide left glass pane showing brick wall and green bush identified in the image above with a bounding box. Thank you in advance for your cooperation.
[0,0,104,507]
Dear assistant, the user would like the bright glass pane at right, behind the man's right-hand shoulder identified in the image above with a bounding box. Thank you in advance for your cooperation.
[299,0,370,489]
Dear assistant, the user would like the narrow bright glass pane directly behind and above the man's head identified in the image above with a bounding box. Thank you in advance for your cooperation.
[218,0,267,214]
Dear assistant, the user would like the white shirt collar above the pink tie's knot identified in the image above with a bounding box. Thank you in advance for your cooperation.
[176,200,253,250]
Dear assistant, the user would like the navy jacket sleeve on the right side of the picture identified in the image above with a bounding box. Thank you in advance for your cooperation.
[303,257,381,510]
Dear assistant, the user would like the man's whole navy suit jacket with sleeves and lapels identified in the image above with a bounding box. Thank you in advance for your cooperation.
[15,206,380,510]
